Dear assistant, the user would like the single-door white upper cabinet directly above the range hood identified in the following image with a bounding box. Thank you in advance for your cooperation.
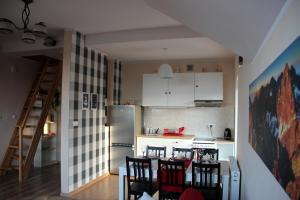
[195,72,223,101]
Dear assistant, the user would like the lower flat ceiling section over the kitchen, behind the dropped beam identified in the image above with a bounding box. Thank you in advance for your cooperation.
[94,37,234,61]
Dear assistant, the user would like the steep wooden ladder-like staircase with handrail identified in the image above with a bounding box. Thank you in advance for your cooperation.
[0,58,62,182]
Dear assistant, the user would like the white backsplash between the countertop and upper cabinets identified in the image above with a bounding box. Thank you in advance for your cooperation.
[144,106,234,137]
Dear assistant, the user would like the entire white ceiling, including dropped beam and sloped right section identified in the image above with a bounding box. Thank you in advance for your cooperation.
[0,0,285,60]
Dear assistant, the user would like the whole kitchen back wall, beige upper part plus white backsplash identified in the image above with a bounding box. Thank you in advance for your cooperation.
[122,58,235,137]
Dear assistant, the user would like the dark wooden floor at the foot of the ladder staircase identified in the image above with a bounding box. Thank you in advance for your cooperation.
[0,165,60,200]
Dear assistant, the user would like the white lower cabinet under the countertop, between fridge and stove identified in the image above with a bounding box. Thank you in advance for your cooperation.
[136,136,192,157]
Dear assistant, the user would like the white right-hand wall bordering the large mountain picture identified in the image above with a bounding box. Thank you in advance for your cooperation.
[237,0,300,200]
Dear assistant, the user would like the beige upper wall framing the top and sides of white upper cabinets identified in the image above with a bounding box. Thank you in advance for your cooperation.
[121,58,234,105]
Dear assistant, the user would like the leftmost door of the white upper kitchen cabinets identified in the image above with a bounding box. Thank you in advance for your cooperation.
[142,74,169,106]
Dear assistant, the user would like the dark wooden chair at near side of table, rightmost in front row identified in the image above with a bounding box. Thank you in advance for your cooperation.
[192,162,221,200]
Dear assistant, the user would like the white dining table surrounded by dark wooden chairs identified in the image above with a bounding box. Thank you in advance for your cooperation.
[119,158,230,200]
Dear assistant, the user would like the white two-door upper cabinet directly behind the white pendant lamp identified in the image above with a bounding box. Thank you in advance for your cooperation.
[142,73,194,107]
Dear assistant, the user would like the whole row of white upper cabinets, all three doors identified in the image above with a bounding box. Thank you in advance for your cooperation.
[142,72,223,107]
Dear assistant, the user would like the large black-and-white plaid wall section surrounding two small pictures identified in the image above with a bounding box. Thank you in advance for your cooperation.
[68,32,108,191]
